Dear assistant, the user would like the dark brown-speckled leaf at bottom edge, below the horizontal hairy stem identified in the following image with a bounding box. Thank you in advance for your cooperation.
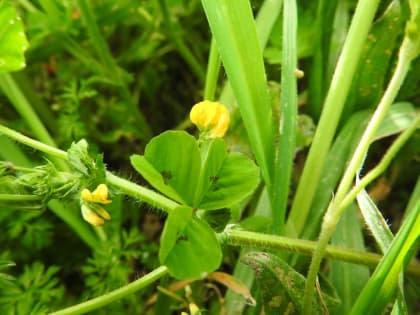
[242,252,338,315]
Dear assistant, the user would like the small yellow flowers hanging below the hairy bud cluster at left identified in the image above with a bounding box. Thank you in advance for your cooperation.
[80,184,112,226]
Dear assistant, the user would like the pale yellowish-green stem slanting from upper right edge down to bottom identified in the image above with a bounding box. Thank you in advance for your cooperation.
[303,37,417,315]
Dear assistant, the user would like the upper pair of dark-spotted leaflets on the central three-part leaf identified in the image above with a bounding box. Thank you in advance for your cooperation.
[131,131,259,210]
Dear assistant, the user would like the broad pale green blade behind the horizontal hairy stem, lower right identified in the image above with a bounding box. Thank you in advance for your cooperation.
[330,204,369,314]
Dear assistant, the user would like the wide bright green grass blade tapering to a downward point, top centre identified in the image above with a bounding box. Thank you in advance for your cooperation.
[202,0,274,193]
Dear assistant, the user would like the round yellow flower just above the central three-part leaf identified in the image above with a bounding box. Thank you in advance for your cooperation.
[190,101,230,138]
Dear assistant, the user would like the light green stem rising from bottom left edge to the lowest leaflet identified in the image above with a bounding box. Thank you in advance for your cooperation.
[50,266,168,315]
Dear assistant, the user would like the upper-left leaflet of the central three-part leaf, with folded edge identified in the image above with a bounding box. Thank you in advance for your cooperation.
[133,131,201,205]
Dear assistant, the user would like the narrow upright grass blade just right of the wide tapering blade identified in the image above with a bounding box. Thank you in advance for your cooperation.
[272,0,298,234]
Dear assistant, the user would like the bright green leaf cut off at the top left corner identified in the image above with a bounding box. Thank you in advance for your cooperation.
[0,1,28,73]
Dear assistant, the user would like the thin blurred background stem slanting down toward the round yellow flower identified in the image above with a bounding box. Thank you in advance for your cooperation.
[158,0,205,82]
